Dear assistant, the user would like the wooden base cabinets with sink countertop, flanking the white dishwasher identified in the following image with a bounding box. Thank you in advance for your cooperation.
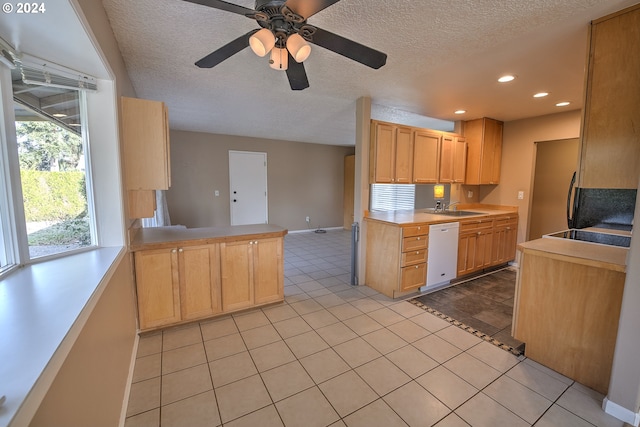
[364,204,518,298]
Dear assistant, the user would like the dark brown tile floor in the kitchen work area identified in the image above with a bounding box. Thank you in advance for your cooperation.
[417,268,523,348]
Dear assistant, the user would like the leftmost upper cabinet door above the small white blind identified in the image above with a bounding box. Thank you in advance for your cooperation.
[370,123,396,184]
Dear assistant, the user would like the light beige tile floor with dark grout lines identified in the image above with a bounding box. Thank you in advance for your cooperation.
[125,230,624,427]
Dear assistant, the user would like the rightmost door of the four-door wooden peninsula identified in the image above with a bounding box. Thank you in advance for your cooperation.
[252,238,284,304]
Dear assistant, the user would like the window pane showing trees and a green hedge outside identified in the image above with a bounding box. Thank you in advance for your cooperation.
[13,85,93,259]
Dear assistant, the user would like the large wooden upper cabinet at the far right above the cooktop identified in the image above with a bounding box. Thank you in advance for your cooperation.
[578,5,640,188]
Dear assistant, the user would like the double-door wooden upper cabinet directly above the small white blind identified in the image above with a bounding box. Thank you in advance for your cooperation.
[370,122,413,184]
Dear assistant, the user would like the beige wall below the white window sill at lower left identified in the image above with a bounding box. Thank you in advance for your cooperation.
[29,255,136,427]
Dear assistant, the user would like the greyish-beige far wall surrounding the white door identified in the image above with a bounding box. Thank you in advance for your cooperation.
[167,130,354,230]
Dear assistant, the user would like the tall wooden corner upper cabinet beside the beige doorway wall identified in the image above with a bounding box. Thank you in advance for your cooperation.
[462,117,503,185]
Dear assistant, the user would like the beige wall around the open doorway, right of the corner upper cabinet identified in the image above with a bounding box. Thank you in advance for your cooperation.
[477,110,581,242]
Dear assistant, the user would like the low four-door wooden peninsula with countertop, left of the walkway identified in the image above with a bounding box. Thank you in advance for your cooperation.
[130,224,287,331]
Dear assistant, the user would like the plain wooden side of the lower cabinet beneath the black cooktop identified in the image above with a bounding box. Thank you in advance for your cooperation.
[512,247,626,395]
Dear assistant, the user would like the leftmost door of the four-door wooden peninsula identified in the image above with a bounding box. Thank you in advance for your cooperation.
[134,249,181,329]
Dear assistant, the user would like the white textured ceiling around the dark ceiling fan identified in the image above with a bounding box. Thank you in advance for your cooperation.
[103,0,637,145]
